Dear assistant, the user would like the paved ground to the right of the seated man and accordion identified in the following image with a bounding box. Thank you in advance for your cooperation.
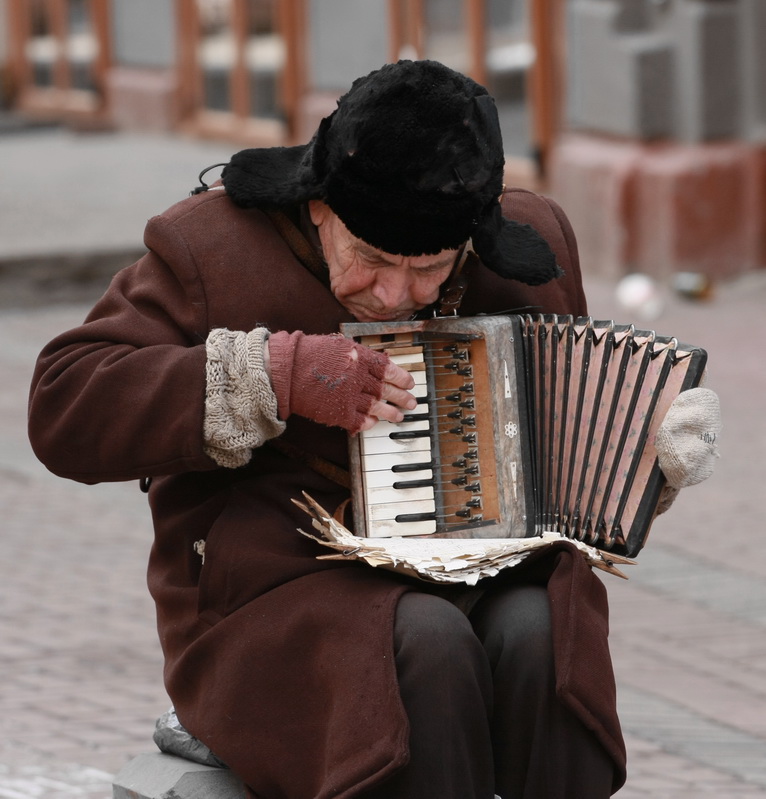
[589,274,766,799]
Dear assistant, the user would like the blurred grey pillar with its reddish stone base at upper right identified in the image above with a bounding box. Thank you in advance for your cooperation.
[550,0,766,278]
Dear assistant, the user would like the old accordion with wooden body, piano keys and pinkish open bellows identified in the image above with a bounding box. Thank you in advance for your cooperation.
[342,316,706,557]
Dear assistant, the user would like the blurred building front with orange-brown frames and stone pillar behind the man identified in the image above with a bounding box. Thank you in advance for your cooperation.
[0,0,766,286]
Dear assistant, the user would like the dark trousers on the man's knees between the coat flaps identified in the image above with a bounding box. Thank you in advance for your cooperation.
[364,585,613,799]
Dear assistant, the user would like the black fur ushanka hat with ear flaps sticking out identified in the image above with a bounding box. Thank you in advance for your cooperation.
[222,61,561,285]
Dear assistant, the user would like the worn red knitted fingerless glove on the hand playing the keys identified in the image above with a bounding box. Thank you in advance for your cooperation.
[269,331,389,433]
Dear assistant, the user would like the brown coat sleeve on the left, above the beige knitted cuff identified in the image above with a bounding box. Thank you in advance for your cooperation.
[28,212,215,483]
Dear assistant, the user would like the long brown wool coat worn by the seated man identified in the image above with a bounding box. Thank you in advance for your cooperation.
[29,190,624,799]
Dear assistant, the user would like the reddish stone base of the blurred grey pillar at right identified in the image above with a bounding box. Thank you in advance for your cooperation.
[551,138,766,280]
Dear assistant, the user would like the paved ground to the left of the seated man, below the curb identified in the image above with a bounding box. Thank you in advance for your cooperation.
[0,308,169,799]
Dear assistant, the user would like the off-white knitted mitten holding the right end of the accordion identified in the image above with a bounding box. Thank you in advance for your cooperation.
[654,388,721,489]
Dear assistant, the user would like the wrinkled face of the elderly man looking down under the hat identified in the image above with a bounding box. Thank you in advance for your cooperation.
[309,200,457,322]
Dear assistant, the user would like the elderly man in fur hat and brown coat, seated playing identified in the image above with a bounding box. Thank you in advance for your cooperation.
[25,62,720,799]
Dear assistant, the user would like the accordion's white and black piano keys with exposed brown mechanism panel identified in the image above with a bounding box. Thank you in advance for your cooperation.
[344,316,532,538]
